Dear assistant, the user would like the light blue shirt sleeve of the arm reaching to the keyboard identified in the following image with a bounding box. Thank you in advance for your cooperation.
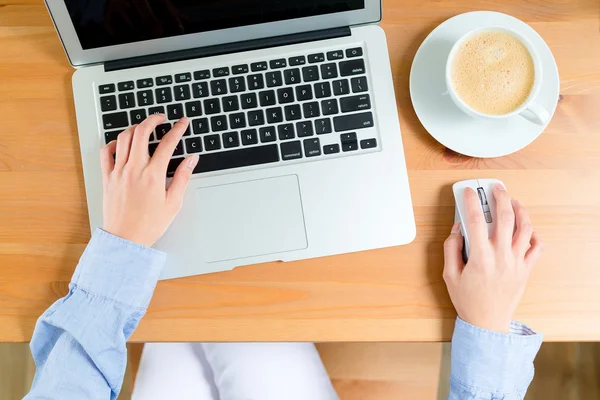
[25,229,166,400]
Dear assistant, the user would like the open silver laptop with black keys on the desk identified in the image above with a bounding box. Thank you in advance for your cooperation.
[46,0,415,279]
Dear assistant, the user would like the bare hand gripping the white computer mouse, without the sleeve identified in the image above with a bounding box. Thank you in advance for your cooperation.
[444,185,543,333]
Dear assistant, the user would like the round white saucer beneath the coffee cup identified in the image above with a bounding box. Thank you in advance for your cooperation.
[410,11,560,158]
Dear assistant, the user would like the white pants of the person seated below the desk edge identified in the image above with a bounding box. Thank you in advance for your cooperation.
[131,343,338,400]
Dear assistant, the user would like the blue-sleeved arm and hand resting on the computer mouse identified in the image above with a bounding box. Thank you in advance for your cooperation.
[444,187,543,400]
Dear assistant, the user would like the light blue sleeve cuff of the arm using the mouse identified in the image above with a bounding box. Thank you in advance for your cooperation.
[448,318,543,400]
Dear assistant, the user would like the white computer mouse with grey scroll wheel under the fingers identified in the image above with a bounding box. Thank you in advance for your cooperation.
[452,179,506,262]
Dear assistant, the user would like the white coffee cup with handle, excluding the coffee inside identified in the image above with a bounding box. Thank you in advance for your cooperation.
[446,26,550,125]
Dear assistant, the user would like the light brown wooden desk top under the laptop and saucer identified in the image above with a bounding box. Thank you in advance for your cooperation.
[0,0,600,341]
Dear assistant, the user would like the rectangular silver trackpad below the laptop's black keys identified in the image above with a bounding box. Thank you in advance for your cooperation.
[196,175,307,262]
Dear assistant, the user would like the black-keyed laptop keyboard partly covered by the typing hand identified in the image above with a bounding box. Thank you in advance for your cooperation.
[98,47,377,176]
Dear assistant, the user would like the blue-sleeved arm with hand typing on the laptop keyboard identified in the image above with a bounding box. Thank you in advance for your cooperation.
[25,115,198,400]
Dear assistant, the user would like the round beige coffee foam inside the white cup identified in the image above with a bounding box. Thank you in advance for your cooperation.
[451,31,535,115]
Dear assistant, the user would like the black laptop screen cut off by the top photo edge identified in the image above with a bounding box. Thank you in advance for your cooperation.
[65,0,365,50]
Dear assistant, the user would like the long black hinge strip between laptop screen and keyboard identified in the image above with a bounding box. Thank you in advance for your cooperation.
[104,26,351,72]
